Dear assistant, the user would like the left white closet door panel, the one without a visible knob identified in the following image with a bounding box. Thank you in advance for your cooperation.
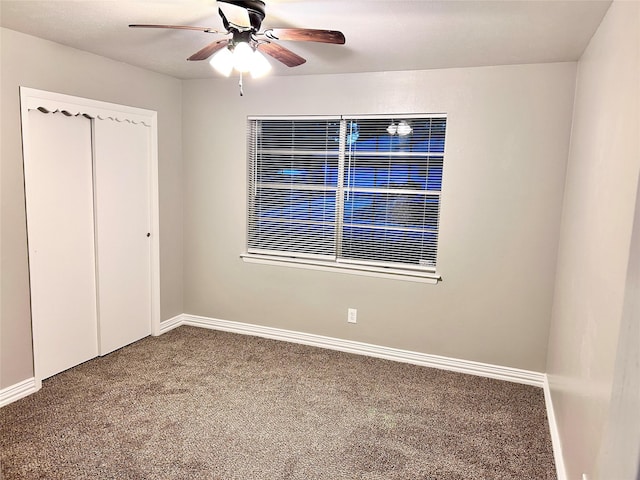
[24,110,98,379]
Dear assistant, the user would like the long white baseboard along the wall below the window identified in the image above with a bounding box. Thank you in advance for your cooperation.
[160,314,545,388]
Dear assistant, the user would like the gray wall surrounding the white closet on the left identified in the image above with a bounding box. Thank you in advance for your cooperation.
[0,29,183,388]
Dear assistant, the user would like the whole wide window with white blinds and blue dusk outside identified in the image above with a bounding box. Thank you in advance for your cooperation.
[246,115,446,279]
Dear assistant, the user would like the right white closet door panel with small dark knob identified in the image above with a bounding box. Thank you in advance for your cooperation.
[94,119,151,355]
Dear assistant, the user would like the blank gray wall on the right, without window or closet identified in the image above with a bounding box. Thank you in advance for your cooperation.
[547,1,640,480]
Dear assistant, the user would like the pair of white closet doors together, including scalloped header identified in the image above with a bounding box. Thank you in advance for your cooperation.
[21,95,159,381]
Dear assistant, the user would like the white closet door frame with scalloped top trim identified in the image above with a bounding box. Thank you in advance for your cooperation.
[20,87,160,390]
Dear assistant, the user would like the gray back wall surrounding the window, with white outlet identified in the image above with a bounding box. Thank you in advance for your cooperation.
[183,63,576,372]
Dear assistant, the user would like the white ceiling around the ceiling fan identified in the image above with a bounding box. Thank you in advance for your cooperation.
[0,0,611,79]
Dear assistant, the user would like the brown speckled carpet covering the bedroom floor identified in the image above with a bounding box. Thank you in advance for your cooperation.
[0,327,555,480]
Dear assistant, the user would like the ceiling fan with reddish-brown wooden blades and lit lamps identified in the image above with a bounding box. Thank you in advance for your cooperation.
[129,0,345,94]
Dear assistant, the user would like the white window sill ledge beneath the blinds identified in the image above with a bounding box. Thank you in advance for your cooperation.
[240,253,442,285]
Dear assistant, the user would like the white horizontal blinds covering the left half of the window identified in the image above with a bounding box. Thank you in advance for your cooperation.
[248,118,341,259]
